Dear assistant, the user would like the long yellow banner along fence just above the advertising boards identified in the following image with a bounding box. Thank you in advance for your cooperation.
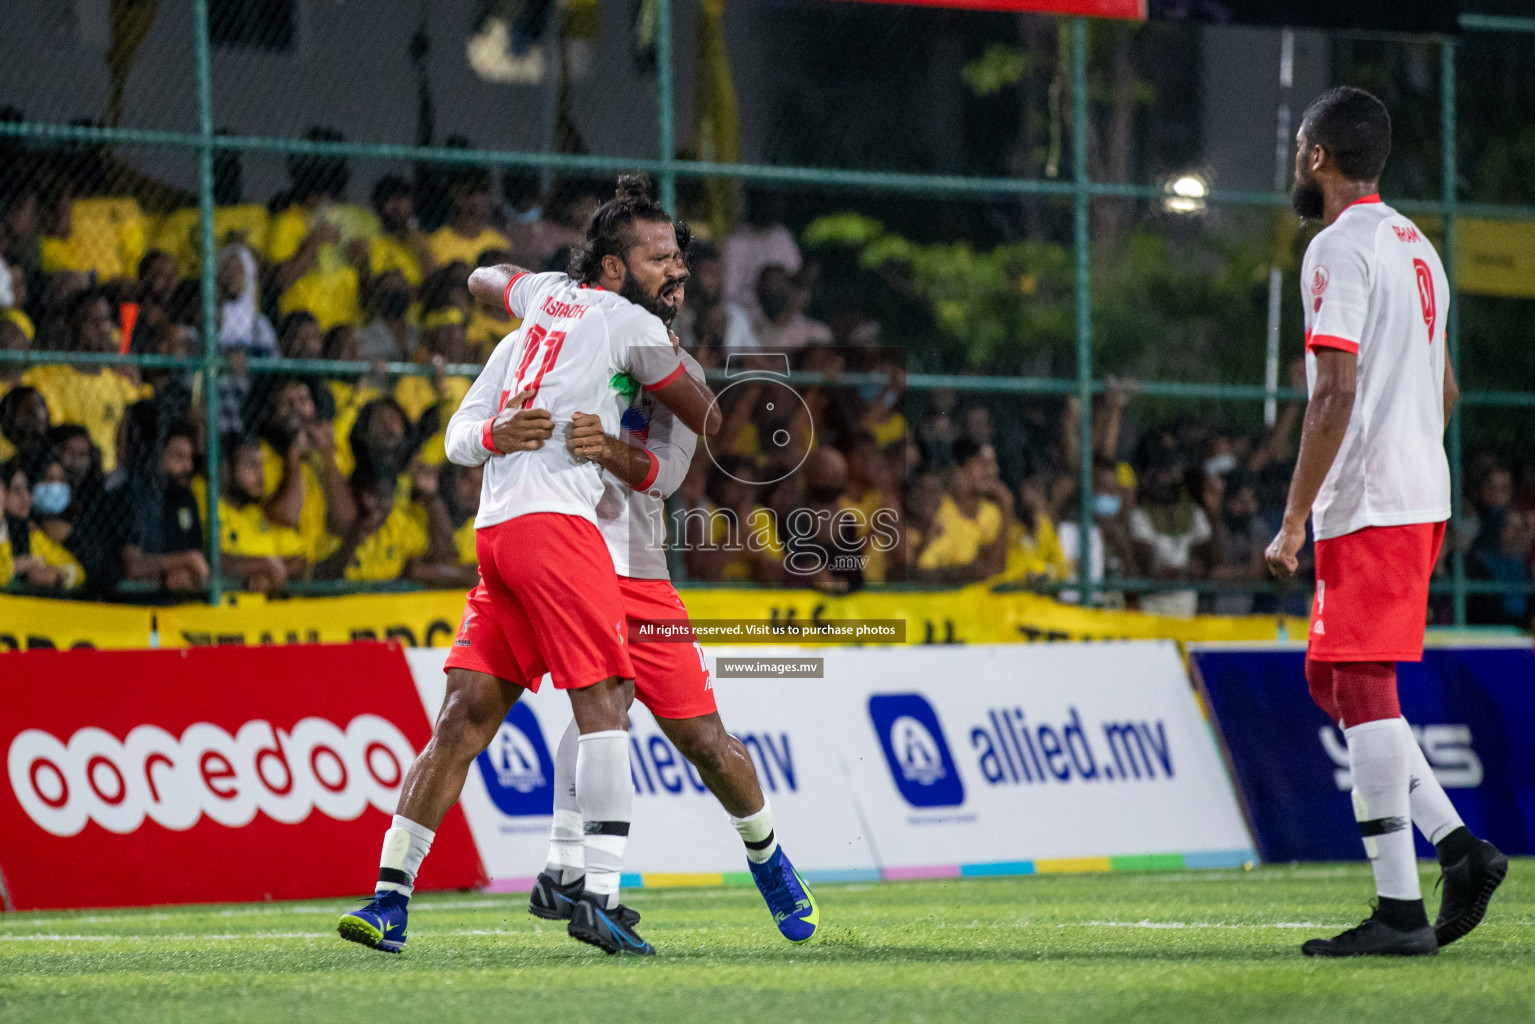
[0,586,1306,651]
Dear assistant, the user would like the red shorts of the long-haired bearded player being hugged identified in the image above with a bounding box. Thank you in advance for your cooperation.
[447,513,634,692]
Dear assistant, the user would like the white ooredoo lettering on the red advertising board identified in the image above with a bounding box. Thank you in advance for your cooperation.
[6,714,416,837]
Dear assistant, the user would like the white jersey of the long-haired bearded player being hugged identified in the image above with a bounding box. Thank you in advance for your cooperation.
[447,273,683,530]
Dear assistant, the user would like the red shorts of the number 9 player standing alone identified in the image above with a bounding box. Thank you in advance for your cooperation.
[1306,522,1444,662]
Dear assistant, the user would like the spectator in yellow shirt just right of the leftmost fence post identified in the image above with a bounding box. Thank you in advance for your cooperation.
[200,436,307,594]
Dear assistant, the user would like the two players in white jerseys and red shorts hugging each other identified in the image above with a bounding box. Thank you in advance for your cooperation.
[338,177,820,955]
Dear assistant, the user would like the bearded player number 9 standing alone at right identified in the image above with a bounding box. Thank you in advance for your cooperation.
[1266,86,1507,956]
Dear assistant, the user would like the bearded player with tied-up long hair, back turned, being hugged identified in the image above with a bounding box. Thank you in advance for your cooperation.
[338,177,718,955]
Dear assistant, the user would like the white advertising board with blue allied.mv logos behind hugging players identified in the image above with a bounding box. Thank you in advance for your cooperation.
[407,642,1253,889]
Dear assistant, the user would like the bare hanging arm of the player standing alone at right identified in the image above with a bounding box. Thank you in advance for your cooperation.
[1265,348,1358,579]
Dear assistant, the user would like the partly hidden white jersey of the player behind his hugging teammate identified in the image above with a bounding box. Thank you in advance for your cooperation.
[597,352,705,579]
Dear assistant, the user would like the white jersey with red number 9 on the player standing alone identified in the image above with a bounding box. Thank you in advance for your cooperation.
[1300,195,1449,540]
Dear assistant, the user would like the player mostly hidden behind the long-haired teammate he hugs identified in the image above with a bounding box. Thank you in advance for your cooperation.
[497,267,820,943]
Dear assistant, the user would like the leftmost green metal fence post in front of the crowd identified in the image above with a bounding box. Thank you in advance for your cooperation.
[192,0,224,605]
